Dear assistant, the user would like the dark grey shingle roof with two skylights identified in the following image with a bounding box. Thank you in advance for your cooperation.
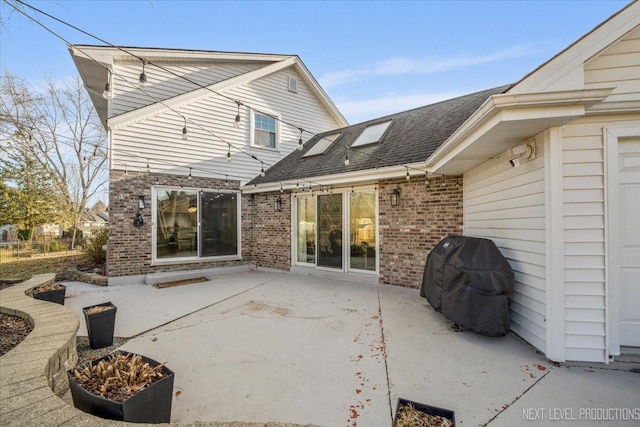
[247,85,510,186]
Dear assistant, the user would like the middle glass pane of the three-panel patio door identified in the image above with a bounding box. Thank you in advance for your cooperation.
[317,194,343,269]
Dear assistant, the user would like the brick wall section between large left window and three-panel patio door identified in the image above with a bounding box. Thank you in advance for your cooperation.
[242,191,291,270]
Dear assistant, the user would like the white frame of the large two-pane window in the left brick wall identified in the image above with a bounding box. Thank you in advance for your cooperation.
[151,185,242,265]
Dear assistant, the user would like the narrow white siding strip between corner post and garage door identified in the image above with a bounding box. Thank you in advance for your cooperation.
[563,115,640,362]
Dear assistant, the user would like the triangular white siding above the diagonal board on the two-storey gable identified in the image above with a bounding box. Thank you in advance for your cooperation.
[111,61,264,116]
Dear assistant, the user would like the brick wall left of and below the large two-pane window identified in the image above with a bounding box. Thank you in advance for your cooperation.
[107,170,244,277]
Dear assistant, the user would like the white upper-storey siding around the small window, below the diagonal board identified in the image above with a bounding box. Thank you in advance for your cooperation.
[110,69,340,182]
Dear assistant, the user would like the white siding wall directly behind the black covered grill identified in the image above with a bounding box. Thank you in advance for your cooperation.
[464,141,546,351]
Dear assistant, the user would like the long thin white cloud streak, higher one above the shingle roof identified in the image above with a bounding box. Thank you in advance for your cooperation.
[318,43,537,88]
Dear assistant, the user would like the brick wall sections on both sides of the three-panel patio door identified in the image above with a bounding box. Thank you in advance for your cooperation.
[242,177,463,288]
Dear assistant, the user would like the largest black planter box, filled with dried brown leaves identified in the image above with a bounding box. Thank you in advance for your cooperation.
[67,352,174,424]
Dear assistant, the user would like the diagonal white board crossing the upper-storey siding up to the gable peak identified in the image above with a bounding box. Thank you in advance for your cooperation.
[107,57,295,130]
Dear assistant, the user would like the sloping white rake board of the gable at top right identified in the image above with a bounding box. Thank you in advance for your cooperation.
[509,1,640,93]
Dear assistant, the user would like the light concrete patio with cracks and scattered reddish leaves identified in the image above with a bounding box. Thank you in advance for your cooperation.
[65,269,640,427]
